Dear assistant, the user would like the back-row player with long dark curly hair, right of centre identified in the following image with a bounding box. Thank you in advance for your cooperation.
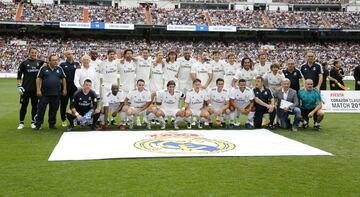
[233,57,256,88]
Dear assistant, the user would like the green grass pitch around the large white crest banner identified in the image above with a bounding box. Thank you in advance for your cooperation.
[0,79,360,196]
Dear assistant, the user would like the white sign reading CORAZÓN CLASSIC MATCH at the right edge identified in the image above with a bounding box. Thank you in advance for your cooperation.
[320,90,360,113]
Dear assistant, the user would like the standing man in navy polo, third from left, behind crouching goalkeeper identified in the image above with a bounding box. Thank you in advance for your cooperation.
[60,50,80,127]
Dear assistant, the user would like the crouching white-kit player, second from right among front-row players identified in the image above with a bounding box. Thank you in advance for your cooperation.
[208,78,230,127]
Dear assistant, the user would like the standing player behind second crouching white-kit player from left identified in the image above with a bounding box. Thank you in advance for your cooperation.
[135,49,153,90]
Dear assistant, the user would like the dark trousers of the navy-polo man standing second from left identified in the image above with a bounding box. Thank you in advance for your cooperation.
[36,96,60,126]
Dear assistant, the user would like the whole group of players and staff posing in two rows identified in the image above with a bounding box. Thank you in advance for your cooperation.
[17,45,360,131]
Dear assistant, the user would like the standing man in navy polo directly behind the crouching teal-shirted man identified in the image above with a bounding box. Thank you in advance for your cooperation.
[300,51,326,91]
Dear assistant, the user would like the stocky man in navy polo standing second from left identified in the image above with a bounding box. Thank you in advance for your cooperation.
[35,54,66,130]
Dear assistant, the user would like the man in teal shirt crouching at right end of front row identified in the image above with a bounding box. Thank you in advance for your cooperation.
[298,79,324,131]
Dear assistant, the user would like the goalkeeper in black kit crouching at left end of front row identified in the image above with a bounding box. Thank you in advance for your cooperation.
[66,79,100,131]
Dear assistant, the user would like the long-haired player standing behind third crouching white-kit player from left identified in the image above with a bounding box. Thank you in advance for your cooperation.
[164,51,180,86]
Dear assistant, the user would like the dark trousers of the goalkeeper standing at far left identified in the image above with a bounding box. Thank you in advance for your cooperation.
[19,91,39,123]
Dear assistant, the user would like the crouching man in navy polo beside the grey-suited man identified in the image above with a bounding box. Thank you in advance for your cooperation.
[254,76,276,129]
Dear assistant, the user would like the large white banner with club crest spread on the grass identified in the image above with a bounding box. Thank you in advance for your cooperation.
[49,129,332,161]
